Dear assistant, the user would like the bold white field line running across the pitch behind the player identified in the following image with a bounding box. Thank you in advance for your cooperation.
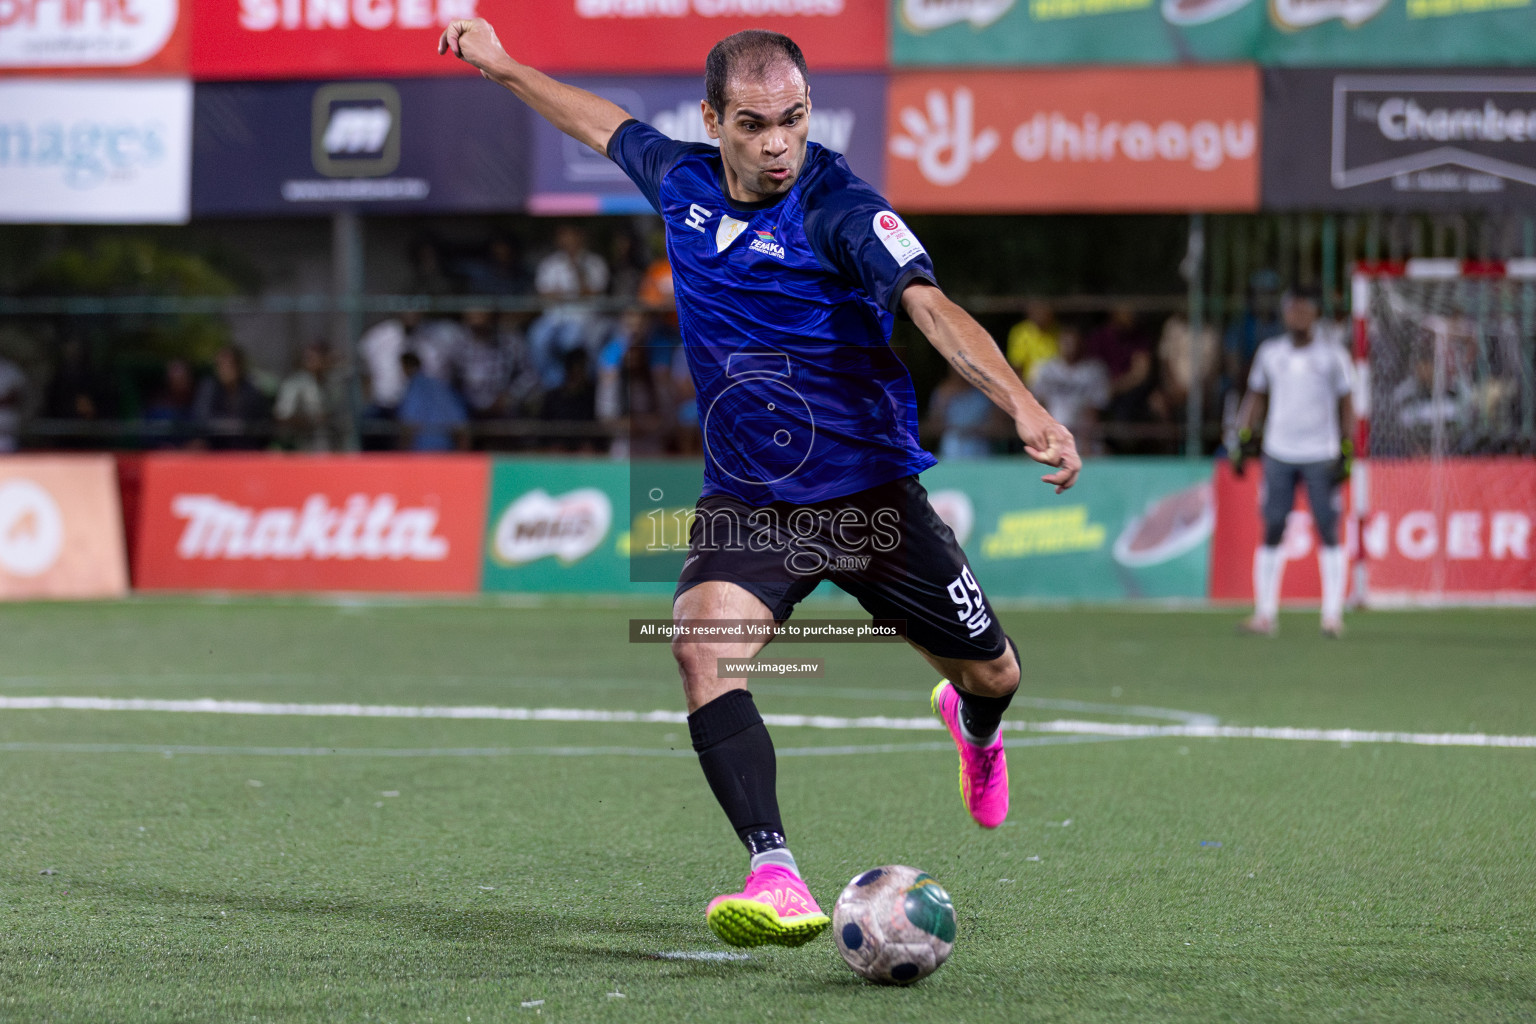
[0,697,1536,748]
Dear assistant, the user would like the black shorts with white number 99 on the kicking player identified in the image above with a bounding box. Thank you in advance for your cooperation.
[674,476,1008,662]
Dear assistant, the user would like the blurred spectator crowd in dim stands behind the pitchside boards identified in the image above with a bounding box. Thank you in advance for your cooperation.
[0,223,1382,459]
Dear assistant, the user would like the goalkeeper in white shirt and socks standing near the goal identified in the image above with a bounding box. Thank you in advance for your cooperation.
[1232,289,1355,639]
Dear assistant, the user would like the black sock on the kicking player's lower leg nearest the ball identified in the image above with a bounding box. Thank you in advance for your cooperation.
[688,689,783,854]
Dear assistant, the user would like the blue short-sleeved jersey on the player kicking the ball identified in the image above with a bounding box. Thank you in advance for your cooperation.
[608,121,935,505]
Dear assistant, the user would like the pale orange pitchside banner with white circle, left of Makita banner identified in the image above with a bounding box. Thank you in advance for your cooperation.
[0,454,127,600]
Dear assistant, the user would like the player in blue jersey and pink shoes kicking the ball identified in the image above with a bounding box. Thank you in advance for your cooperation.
[438,18,1081,946]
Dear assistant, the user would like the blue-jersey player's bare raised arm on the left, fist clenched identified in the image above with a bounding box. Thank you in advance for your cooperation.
[438,18,630,157]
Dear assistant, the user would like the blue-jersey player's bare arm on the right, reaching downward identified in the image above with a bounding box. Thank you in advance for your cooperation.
[902,282,1083,494]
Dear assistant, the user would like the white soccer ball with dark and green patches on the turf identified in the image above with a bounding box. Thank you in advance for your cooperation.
[833,864,955,986]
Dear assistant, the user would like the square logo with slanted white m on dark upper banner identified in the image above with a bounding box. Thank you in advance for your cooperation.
[310,81,399,178]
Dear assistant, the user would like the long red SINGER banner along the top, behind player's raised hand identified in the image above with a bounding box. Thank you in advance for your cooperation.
[192,0,886,80]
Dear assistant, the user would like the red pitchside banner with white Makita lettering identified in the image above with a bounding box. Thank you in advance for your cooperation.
[134,454,488,594]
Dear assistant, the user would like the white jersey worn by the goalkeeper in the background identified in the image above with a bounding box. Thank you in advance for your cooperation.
[1249,335,1352,462]
